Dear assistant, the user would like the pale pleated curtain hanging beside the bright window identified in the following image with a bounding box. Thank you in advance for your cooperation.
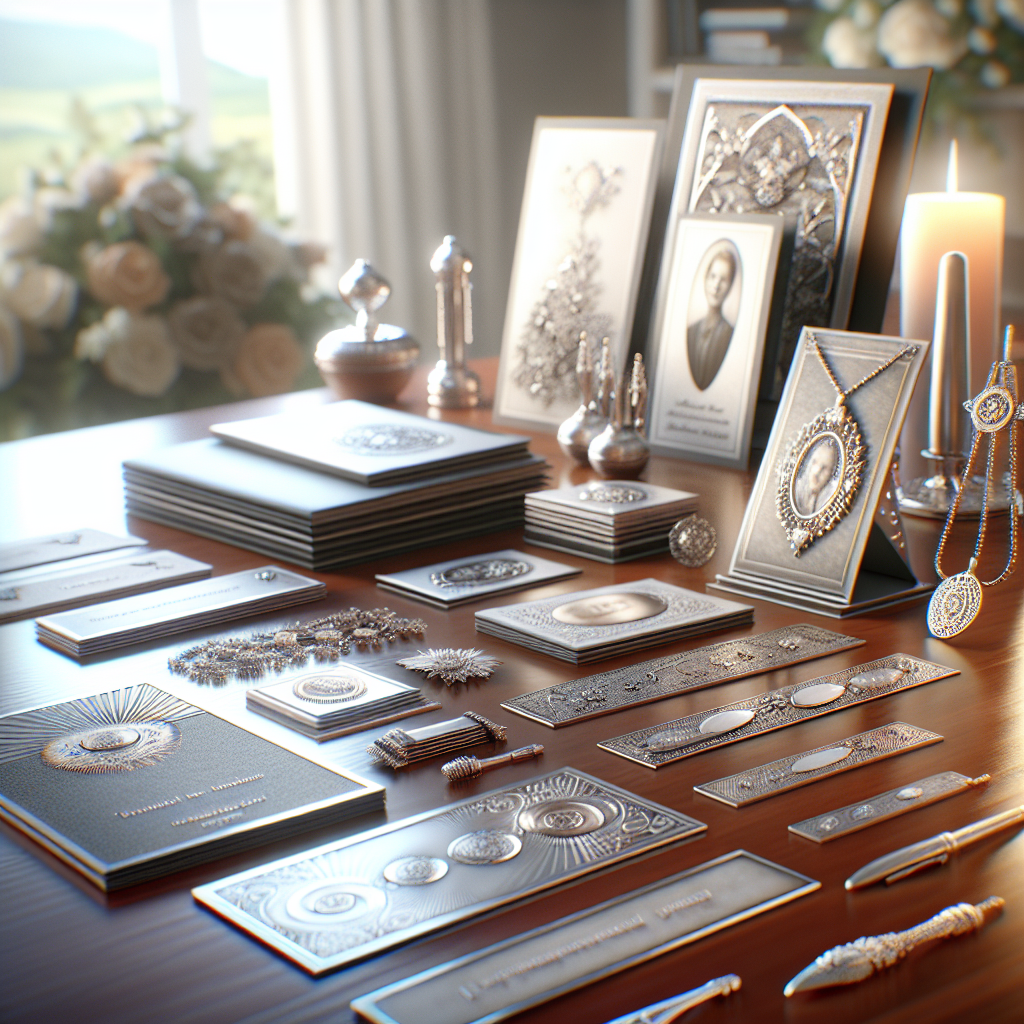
[271,0,499,358]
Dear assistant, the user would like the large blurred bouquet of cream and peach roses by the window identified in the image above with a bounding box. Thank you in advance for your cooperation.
[0,108,345,438]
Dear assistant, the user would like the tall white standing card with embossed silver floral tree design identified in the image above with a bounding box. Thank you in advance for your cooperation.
[494,118,665,430]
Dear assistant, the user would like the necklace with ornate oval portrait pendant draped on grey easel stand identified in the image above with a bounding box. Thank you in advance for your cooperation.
[775,328,918,558]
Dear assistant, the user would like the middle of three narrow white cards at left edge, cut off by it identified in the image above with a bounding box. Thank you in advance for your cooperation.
[0,551,213,623]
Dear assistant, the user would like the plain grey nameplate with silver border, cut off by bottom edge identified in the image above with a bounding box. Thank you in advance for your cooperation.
[352,850,820,1024]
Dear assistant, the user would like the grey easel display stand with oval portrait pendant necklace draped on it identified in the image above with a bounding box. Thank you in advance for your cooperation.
[709,328,934,618]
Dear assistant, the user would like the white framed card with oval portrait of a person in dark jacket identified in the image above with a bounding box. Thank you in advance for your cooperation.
[648,214,783,468]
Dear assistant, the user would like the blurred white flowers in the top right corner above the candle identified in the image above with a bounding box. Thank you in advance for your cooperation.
[809,0,1024,122]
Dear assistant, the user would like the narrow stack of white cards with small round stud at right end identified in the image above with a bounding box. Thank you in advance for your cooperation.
[36,565,327,657]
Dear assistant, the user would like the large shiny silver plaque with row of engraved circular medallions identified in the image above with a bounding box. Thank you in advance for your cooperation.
[194,768,706,974]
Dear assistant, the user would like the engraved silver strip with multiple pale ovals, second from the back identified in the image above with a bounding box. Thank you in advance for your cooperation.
[597,654,958,768]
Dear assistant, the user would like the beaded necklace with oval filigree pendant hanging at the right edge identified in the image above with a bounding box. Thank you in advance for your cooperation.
[928,327,1024,640]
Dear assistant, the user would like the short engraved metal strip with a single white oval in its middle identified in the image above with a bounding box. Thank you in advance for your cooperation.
[693,722,943,807]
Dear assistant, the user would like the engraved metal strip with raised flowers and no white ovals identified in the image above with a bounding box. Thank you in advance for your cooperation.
[502,625,864,729]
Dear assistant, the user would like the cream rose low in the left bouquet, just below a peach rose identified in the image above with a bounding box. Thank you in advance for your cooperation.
[86,306,181,398]
